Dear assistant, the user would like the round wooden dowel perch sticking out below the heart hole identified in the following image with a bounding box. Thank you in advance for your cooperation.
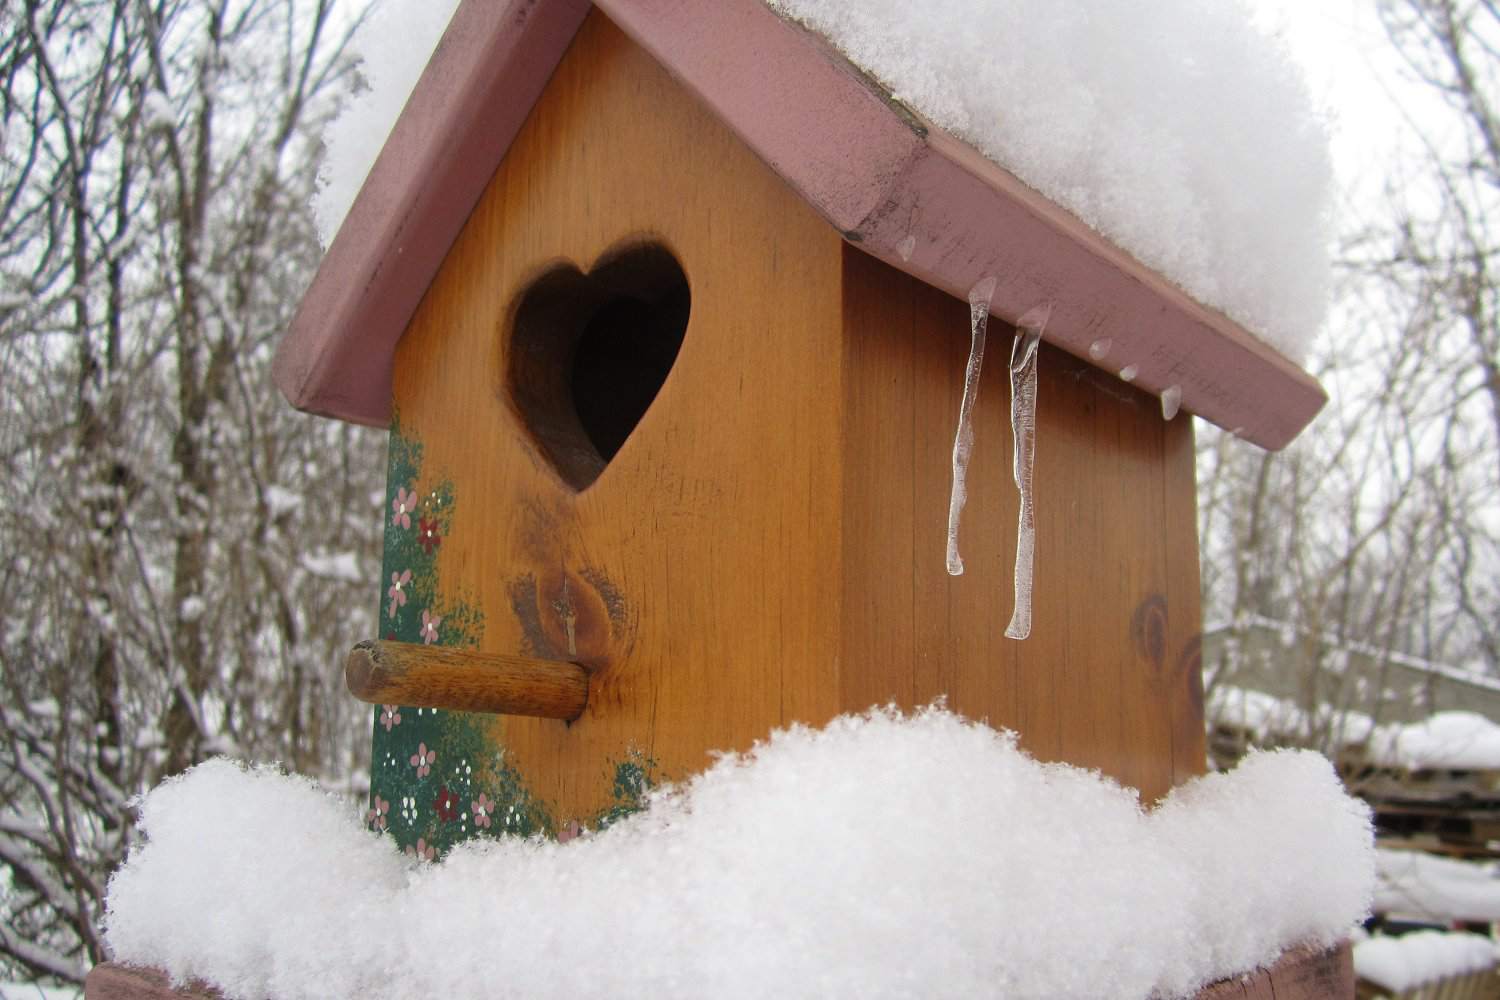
[344,639,588,721]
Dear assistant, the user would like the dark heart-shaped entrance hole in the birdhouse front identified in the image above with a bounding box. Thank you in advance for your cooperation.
[507,243,692,490]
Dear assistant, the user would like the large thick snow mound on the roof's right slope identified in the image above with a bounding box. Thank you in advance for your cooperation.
[767,0,1334,358]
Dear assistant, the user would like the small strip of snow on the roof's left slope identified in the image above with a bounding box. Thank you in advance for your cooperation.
[312,0,459,246]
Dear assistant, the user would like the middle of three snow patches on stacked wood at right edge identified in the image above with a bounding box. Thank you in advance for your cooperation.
[1374,850,1500,924]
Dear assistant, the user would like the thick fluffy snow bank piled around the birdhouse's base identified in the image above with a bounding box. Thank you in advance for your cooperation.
[107,709,1374,999]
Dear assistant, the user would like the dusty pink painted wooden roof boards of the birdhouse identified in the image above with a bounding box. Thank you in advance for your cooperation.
[276,0,1326,448]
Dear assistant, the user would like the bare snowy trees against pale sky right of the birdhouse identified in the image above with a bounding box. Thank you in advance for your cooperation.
[1200,0,1500,758]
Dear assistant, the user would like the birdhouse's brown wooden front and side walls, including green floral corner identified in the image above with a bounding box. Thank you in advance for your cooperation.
[372,10,1203,852]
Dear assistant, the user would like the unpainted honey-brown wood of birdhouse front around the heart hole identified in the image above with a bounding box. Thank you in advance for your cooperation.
[396,12,842,817]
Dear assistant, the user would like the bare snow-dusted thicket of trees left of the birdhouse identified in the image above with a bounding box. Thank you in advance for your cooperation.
[0,0,381,982]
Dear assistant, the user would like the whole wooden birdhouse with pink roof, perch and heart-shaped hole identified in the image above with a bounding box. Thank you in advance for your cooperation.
[278,0,1323,856]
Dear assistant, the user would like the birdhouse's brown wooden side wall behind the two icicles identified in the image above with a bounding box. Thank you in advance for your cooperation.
[840,249,1203,801]
